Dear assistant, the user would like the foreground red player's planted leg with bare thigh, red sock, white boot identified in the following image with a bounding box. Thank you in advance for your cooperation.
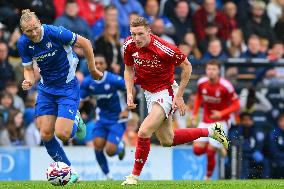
[122,102,166,185]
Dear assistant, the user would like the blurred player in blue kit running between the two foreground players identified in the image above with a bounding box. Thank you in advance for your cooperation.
[81,55,131,179]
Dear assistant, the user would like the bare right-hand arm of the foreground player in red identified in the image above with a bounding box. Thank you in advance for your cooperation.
[172,58,192,116]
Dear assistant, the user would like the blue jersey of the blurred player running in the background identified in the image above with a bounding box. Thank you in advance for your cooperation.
[81,71,127,123]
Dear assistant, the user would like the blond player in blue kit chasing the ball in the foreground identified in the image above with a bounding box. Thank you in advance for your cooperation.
[17,9,103,184]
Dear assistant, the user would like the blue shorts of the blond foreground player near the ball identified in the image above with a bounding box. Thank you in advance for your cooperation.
[35,82,80,120]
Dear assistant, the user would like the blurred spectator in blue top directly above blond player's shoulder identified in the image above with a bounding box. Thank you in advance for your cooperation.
[54,0,93,41]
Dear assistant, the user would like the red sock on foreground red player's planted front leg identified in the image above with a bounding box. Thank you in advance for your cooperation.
[132,137,150,176]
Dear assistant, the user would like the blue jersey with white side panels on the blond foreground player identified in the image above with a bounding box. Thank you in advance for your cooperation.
[17,24,78,89]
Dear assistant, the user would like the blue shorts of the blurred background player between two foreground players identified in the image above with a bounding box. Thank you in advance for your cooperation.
[92,121,126,145]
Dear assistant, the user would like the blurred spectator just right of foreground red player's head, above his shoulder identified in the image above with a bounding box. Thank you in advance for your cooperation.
[151,18,175,45]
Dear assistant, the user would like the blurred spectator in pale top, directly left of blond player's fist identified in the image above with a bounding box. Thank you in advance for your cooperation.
[4,81,25,113]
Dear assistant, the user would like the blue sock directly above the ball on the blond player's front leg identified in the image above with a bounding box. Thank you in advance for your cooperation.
[43,136,71,166]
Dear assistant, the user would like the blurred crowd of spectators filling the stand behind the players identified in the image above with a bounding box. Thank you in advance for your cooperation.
[0,0,284,178]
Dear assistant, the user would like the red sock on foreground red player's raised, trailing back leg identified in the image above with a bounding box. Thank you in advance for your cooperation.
[172,128,208,146]
